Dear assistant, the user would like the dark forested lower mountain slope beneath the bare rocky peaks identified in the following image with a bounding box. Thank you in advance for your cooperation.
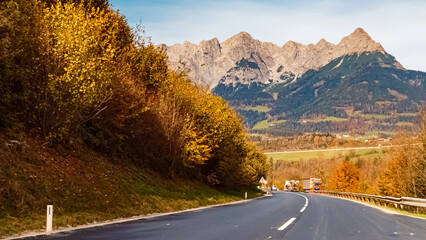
[213,52,426,135]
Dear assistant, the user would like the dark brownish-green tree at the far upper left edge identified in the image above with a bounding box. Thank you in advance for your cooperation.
[0,0,43,129]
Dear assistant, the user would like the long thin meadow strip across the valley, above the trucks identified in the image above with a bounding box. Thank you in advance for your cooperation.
[266,149,383,162]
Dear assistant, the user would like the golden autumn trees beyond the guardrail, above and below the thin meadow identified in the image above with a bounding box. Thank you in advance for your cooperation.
[269,112,426,198]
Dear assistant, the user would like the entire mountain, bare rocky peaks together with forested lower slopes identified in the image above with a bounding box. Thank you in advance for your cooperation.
[166,28,426,135]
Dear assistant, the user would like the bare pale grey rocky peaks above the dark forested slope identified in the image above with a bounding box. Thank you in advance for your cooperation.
[165,28,392,88]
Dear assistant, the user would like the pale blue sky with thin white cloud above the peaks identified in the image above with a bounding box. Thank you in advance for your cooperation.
[110,0,426,71]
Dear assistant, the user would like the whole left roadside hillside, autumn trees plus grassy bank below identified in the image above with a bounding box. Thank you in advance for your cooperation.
[0,0,269,234]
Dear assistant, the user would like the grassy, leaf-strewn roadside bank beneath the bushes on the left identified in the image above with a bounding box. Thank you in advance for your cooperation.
[0,136,261,236]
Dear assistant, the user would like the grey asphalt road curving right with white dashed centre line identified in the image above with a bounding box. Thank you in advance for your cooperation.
[19,192,426,240]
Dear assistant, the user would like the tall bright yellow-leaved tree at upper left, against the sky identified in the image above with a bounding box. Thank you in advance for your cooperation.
[39,2,131,139]
